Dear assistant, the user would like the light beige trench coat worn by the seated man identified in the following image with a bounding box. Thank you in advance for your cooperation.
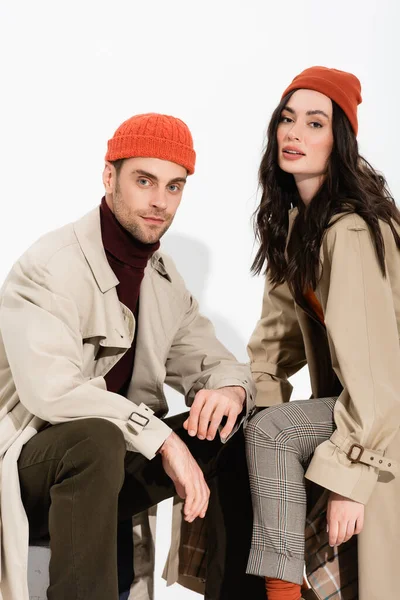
[0,208,253,600]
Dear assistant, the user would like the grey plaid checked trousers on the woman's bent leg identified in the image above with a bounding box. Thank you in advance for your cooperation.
[245,398,336,584]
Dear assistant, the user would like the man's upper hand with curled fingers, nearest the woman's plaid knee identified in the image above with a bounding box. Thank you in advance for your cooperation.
[183,386,246,440]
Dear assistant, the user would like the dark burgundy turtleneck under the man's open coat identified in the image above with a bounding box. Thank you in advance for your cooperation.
[100,198,160,395]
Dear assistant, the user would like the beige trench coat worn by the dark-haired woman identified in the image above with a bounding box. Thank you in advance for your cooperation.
[249,209,400,600]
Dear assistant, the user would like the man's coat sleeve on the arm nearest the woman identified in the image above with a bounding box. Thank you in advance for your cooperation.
[165,290,254,430]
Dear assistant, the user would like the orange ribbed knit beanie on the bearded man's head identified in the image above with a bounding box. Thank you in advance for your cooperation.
[106,113,196,175]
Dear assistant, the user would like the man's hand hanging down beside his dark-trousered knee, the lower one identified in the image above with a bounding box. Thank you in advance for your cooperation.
[159,432,210,523]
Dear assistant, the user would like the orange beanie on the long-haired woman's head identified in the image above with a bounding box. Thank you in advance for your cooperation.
[282,67,362,135]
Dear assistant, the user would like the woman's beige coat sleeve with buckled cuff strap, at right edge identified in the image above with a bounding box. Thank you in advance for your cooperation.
[306,215,400,504]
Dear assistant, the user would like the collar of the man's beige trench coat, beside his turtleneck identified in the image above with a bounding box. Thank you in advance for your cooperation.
[73,207,171,294]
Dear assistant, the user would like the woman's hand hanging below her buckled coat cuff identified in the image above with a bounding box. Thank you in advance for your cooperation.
[327,492,364,546]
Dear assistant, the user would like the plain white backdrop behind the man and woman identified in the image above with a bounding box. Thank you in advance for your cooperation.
[0,0,400,600]
